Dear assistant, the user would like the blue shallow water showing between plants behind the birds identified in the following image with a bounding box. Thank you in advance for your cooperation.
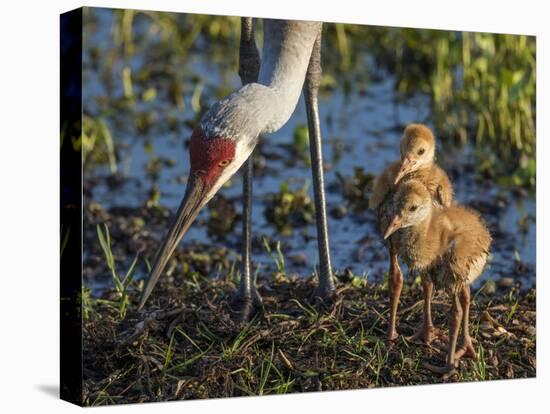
[84,9,535,287]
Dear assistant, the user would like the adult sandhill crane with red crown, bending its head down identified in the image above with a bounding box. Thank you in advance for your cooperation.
[139,18,335,319]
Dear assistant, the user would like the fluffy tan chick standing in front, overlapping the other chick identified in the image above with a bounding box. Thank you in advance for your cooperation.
[384,180,491,373]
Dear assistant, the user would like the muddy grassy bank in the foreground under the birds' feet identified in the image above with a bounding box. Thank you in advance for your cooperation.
[84,274,536,405]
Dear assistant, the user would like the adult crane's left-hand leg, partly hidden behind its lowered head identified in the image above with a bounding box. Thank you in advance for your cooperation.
[232,17,262,321]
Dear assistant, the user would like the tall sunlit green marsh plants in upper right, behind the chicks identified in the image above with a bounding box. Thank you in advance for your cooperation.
[364,28,536,187]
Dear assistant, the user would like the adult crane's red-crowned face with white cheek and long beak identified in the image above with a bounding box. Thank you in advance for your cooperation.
[138,127,254,309]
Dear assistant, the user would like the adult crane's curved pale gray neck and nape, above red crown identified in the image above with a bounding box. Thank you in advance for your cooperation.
[201,20,322,139]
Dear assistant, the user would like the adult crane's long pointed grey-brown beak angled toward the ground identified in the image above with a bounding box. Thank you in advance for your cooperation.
[138,176,208,310]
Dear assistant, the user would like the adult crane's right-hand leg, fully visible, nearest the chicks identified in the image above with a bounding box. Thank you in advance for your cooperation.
[304,31,336,300]
